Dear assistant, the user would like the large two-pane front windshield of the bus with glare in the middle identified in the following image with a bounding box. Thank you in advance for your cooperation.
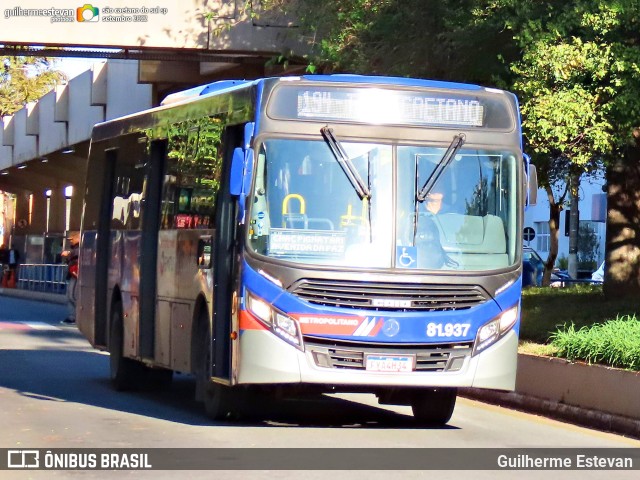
[248,138,519,271]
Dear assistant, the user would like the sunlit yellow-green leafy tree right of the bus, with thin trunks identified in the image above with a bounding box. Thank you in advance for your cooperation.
[503,0,640,283]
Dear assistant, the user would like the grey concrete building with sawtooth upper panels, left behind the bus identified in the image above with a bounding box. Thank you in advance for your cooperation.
[0,61,153,263]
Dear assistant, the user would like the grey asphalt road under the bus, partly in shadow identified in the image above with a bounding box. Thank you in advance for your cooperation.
[0,296,640,479]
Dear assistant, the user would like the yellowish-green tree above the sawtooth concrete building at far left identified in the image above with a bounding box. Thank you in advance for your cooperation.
[0,56,66,115]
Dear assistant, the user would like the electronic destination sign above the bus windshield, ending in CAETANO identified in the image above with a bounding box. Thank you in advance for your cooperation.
[267,85,513,129]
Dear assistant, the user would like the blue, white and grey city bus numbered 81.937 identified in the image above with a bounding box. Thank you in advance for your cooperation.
[77,75,527,424]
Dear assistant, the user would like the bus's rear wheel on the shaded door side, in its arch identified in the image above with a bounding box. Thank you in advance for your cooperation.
[109,302,144,391]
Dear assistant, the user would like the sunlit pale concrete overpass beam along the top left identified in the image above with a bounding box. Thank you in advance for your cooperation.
[0,0,308,55]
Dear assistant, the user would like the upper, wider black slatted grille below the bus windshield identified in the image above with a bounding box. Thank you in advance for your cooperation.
[290,279,489,312]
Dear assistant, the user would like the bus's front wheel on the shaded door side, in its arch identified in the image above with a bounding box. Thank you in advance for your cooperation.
[194,316,233,420]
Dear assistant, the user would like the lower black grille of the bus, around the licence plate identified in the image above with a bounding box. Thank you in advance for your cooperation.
[305,337,473,372]
